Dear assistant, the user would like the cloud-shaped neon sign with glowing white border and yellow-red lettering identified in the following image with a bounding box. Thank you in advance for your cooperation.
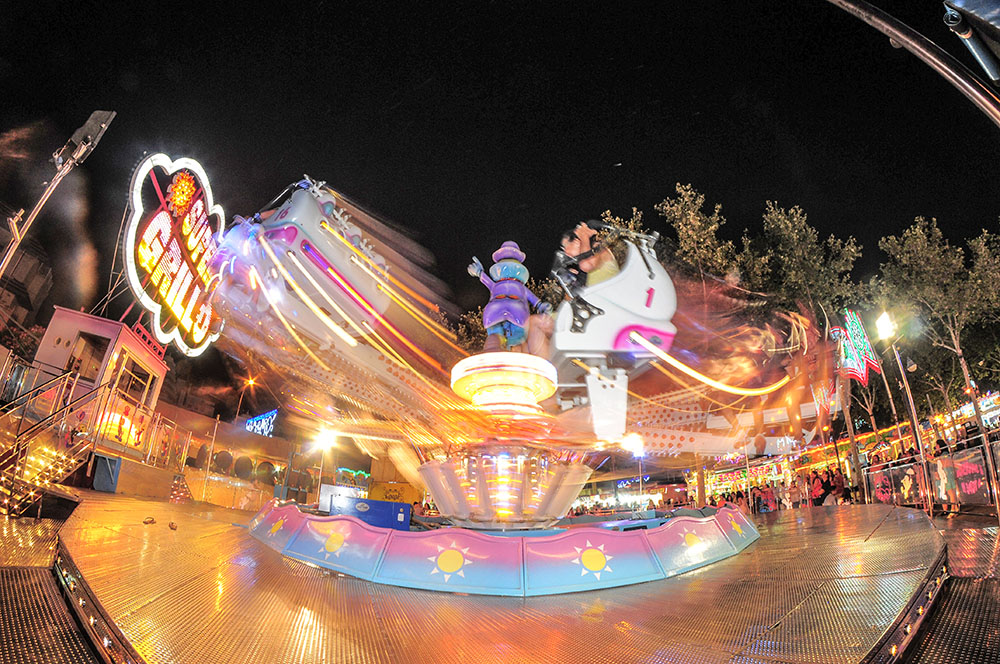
[124,154,225,357]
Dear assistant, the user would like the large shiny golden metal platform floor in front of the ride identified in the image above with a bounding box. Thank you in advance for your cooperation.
[60,494,944,664]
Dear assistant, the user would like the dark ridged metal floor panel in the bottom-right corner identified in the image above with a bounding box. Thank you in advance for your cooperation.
[905,578,1000,664]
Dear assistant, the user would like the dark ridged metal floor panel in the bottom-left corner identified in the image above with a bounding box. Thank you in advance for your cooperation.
[0,567,100,664]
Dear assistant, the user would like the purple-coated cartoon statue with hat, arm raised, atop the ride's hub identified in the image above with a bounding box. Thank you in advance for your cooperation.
[468,240,552,351]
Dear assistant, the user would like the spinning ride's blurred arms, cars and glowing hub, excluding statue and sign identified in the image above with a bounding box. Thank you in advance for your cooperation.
[205,172,820,529]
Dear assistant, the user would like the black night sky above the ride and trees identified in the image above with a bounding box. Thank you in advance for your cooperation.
[0,0,1000,314]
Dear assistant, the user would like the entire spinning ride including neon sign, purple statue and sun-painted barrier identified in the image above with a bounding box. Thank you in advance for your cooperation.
[82,155,821,596]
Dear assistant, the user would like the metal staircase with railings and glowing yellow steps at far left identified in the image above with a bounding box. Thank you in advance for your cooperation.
[0,375,109,517]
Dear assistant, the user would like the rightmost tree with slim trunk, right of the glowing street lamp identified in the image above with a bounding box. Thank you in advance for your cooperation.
[879,217,1000,432]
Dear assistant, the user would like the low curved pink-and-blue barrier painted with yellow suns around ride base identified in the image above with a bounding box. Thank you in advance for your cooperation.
[250,501,760,597]
